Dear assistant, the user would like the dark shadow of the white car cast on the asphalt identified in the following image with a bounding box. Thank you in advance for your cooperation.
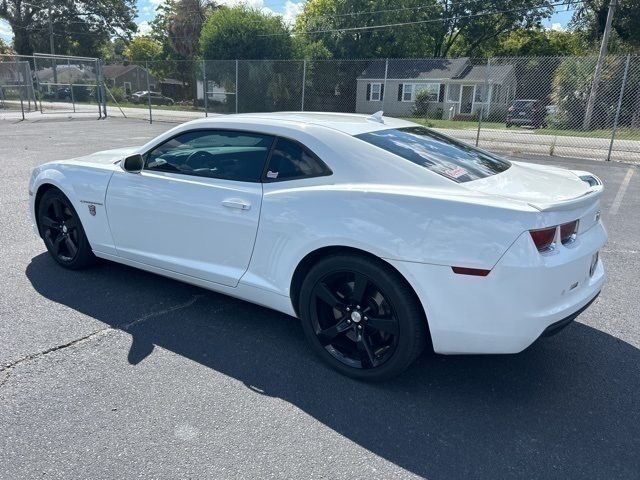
[26,254,640,479]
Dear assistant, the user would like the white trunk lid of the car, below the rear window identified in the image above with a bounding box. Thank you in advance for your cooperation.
[465,162,602,210]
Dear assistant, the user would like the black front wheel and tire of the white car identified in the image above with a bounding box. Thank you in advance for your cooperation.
[37,188,96,270]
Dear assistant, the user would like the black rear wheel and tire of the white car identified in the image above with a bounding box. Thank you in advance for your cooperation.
[298,254,428,381]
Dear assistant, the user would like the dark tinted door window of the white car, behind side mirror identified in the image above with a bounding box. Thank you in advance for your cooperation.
[145,130,274,182]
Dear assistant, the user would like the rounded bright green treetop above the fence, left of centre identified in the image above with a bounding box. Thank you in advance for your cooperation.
[200,5,292,60]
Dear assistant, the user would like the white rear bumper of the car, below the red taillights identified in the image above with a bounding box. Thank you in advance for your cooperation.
[390,222,607,354]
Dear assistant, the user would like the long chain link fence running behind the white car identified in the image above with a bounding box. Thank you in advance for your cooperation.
[0,51,640,162]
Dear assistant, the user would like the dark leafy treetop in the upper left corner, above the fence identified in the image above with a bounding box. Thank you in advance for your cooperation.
[0,0,137,56]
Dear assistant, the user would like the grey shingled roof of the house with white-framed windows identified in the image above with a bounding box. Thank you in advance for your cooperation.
[358,57,513,82]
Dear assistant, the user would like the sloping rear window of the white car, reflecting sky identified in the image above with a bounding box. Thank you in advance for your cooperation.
[356,127,511,183]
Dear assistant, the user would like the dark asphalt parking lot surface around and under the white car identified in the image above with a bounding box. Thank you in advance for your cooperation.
[0,119,640,479]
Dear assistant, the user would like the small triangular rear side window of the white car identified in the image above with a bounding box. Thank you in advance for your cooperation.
[264,137,332,182]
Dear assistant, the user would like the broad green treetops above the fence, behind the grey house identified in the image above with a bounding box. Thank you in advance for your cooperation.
[295,0,553,58]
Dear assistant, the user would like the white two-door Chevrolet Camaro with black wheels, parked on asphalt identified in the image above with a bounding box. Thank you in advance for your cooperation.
[29,112,607,380]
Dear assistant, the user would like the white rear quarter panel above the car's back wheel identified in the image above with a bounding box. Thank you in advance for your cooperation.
[242,180,537,295]
